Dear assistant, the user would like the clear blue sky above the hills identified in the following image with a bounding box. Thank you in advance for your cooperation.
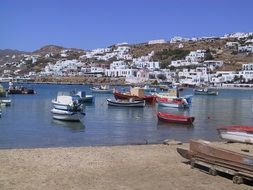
[0,0,253,51]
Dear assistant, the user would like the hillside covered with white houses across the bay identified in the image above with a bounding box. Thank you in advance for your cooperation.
[0,32,253,86]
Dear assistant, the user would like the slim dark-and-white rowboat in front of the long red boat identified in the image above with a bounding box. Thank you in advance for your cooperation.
[107,99,145,107]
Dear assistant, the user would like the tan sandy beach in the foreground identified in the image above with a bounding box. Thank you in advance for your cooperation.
[0,143,253,190]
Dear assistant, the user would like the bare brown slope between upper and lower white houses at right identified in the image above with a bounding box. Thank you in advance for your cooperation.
[131,39,253,71]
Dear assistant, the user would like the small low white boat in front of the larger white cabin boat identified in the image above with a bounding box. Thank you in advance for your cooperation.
[51,108,85,121]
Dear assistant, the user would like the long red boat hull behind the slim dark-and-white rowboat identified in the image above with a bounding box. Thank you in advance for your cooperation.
[113,91,156,104]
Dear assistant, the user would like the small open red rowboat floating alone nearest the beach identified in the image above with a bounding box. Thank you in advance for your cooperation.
[157,112,195,124]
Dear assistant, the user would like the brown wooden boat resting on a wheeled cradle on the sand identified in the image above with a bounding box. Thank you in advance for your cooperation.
[177,140,253,184]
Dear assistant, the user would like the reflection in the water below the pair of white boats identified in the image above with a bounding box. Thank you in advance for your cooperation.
[52,119,85,133]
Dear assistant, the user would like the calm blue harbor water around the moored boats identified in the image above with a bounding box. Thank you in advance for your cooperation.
[0,84,253,148]
